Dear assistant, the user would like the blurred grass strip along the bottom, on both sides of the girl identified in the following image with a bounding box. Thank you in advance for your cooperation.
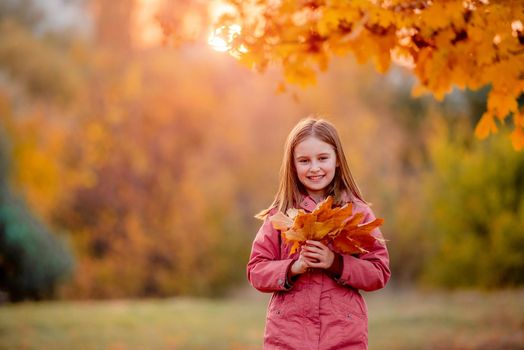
[0,290,524,350]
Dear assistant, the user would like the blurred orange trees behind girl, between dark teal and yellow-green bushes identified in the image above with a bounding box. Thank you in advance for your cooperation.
[5,0,524,298]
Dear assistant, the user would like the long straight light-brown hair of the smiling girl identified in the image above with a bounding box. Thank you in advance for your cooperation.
[255,117,366,219]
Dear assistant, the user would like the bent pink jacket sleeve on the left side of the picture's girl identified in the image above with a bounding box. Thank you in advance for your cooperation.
[247,215,293,292]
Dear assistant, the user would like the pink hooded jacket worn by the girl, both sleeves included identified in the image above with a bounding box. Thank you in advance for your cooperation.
[247,196,391,350]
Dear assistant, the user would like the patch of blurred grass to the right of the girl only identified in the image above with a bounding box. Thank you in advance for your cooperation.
[366,290,524,350]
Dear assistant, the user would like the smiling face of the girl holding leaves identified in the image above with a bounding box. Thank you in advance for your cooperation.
[293,136,338,201]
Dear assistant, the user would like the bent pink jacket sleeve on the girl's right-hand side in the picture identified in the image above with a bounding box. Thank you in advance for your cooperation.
[337,206,391,292]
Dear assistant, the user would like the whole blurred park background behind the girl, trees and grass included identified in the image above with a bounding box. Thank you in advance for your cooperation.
[0,0,524,349]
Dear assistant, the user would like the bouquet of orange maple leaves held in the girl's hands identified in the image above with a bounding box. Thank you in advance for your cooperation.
[269,196,384,255]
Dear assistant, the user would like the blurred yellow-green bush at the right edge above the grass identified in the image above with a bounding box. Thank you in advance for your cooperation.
[421,125,524,288]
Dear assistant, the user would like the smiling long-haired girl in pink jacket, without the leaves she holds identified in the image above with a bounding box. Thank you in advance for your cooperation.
[247,118,391,350]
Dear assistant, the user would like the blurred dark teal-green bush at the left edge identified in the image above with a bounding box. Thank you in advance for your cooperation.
[0,114,73,301]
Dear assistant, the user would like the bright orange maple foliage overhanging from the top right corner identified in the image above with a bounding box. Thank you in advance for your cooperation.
[206,0,524,150]
